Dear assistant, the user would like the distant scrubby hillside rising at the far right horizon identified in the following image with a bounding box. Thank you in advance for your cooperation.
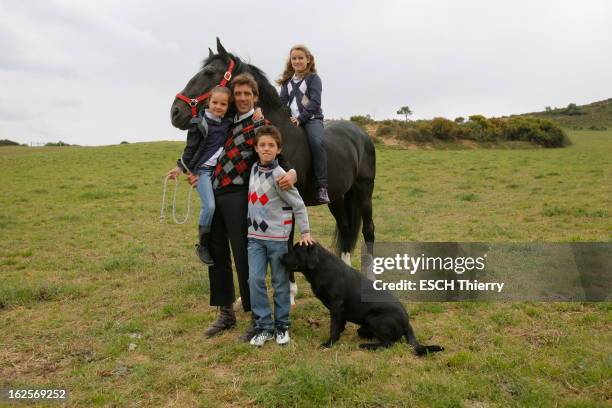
[513,98,612,130]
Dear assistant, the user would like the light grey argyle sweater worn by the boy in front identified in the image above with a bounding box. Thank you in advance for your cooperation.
[247,160,310,241]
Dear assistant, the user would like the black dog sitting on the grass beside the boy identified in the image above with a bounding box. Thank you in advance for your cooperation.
[282,244,444,356]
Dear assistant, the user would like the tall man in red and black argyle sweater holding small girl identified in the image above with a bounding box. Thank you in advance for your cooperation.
[189,74,297,341]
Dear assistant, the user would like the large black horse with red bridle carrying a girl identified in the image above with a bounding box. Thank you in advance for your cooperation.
[170,38,376,264]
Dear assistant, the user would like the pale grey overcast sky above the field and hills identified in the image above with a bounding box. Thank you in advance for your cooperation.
[0,0,612,145]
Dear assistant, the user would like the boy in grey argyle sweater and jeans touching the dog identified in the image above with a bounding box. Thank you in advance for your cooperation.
[247,126,314,347]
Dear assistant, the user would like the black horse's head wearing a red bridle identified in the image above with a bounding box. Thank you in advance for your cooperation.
[170,38,244,130]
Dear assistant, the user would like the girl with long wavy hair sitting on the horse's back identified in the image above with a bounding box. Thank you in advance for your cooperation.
[277,44,329,203]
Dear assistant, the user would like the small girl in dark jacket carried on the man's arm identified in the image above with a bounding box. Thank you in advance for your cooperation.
[167,86,232,265]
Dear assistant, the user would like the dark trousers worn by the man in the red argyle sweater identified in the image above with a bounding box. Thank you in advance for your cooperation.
[208,190,251,312]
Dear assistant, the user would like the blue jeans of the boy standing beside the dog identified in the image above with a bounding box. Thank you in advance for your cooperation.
[248,238,291,330]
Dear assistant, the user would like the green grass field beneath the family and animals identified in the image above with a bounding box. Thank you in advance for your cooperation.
[0,131,612,408]
